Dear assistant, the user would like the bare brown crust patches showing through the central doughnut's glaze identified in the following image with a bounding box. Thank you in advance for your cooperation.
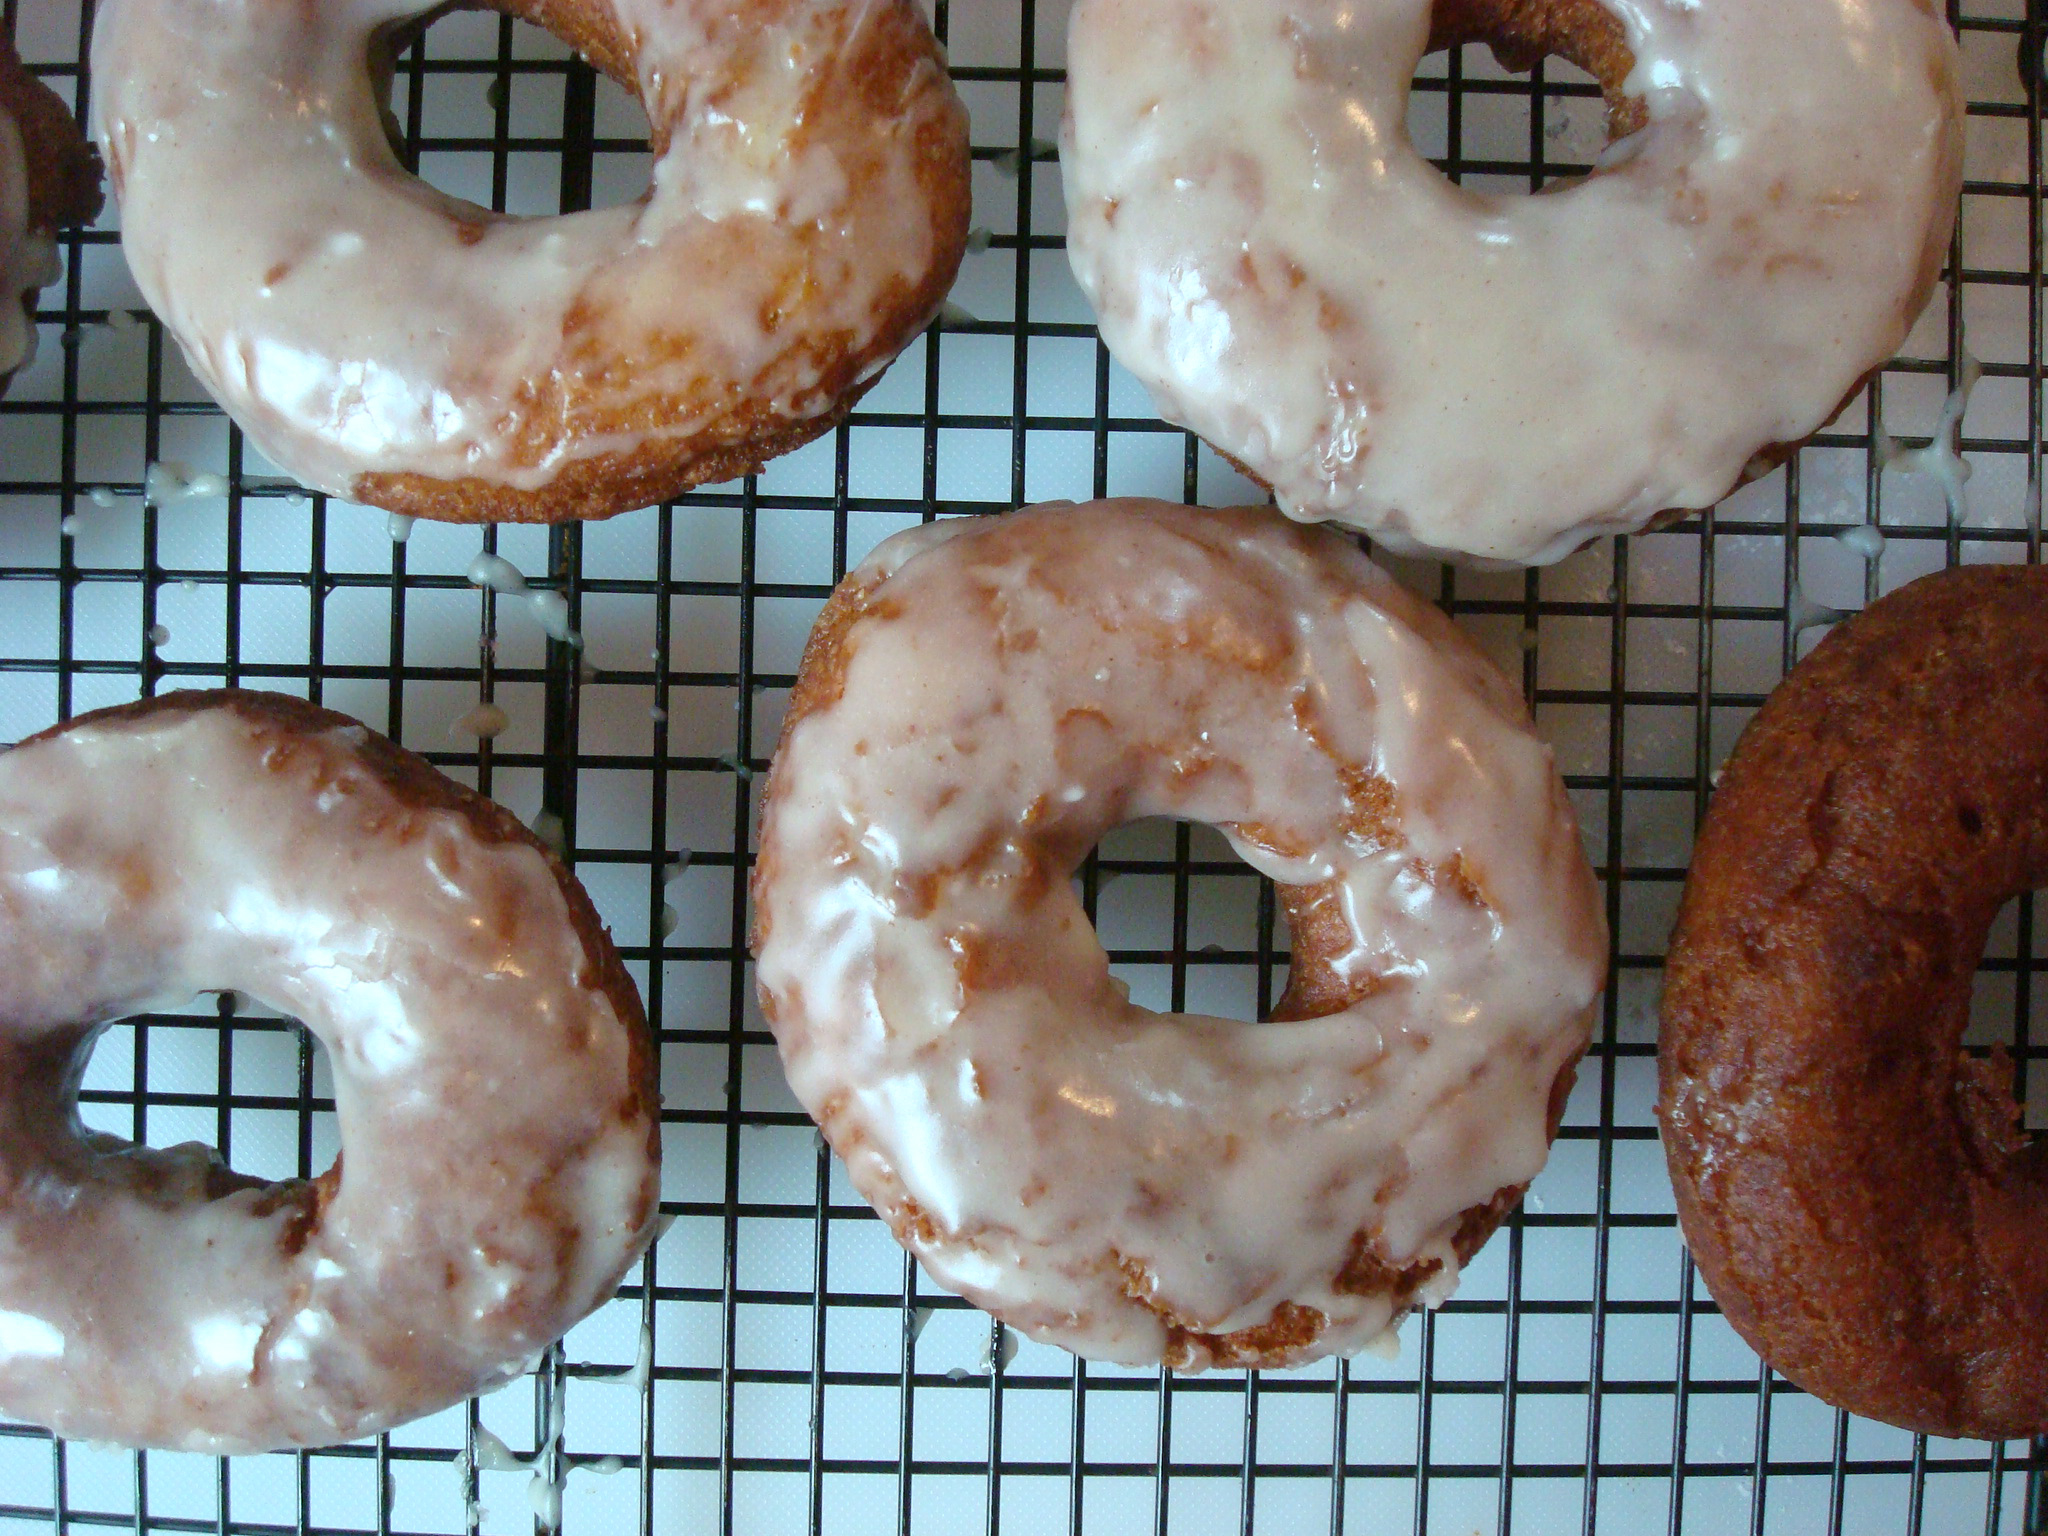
[748,532,1579,1368]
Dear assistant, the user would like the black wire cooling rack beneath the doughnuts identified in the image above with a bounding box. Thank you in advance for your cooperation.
[0,0,2048,1536]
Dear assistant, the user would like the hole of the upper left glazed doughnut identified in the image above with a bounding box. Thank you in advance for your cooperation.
[371,4,653,217]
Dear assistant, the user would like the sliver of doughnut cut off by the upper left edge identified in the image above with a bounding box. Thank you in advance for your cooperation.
[0,35,100,393]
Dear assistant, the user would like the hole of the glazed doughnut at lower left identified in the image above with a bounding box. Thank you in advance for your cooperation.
[78,993,340,1184]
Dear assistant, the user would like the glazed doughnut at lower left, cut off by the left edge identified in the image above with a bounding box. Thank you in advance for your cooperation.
[0,690,657,1454]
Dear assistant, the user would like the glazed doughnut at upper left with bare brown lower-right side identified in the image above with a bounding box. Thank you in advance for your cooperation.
[92,0,969,522]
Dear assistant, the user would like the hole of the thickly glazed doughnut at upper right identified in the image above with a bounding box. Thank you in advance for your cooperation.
[1409,0,1649,190]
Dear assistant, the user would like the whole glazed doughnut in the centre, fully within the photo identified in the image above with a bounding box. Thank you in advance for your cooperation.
[754,502,1606,1370]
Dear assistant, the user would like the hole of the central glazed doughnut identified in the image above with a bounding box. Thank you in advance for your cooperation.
[1097,817,1290,1024]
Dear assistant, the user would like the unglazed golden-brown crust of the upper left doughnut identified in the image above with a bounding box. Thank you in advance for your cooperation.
[350,0,973,522]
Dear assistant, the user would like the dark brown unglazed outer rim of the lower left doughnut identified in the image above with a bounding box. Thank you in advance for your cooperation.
[23,688,662,1187]
